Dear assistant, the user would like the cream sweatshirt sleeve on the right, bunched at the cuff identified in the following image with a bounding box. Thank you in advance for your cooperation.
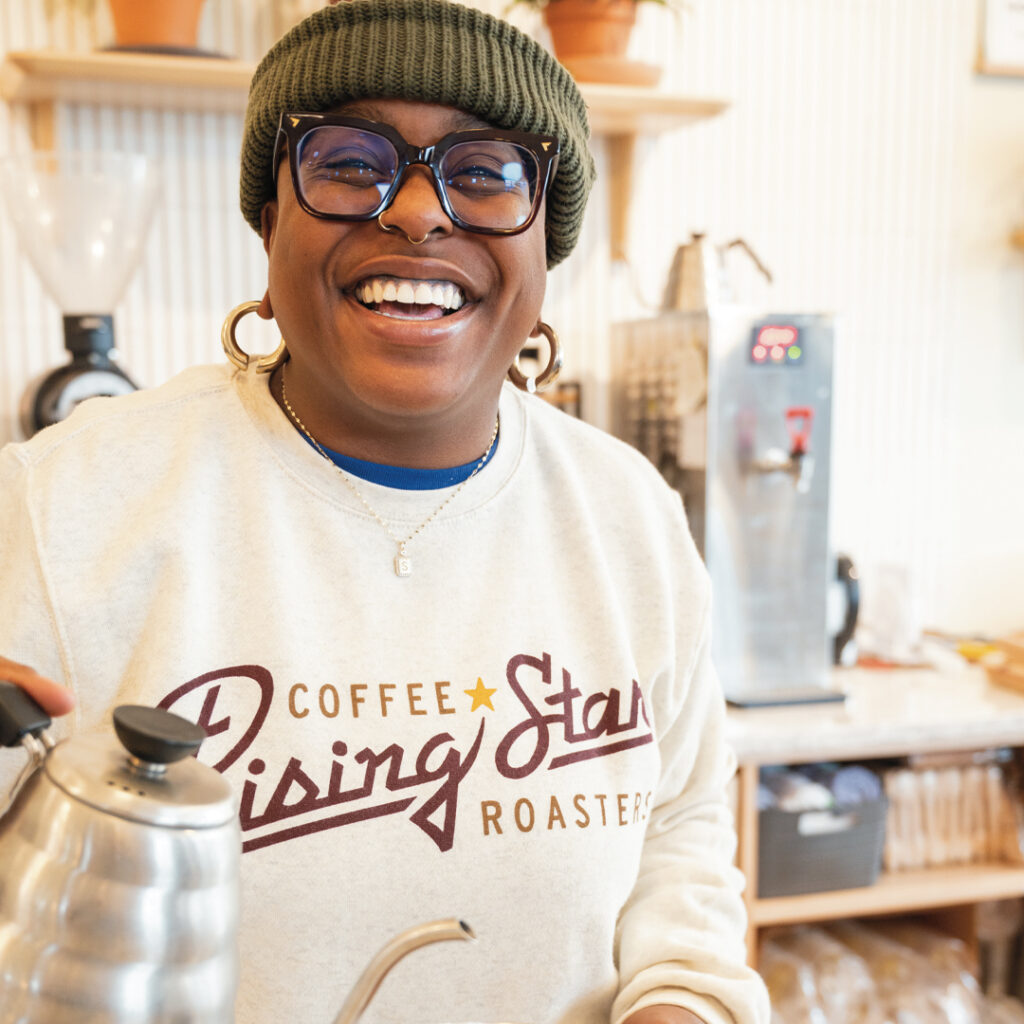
[611,566,770,1024]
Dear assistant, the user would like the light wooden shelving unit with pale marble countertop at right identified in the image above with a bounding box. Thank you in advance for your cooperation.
[729,669,1024,963]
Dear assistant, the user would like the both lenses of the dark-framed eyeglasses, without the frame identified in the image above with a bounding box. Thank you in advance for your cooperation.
[298,125,539,230]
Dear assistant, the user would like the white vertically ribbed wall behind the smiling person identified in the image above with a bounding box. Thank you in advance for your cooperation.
[0,0,1024,634]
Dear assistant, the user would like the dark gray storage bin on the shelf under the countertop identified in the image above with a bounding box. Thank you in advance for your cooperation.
[758,797,889,897]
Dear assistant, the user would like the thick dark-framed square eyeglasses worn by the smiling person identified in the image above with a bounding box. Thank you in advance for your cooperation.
[273,113,558,234]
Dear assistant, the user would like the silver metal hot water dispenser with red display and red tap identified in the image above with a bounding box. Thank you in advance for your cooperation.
[613,306,855,706]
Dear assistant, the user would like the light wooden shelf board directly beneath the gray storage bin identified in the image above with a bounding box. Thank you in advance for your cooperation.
[750,864,1024,928]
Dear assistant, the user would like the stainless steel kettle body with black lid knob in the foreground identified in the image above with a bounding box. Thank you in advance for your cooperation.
[0,683,242,1024]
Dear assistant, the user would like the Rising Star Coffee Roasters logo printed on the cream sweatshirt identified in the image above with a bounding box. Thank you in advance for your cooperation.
[160,652,653,852]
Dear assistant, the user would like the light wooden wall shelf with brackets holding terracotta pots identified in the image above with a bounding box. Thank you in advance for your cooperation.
[0,50,728,259]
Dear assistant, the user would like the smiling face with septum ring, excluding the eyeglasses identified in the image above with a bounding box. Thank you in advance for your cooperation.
[263,99,546,465]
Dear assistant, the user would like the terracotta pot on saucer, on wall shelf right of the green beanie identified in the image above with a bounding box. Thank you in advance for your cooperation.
[515,0,669,85]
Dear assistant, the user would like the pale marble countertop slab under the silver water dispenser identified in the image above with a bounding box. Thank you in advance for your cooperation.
[726,666,1024,765]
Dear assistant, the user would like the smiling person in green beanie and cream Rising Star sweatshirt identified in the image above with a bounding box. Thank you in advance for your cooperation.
[0,0,768,1024]
